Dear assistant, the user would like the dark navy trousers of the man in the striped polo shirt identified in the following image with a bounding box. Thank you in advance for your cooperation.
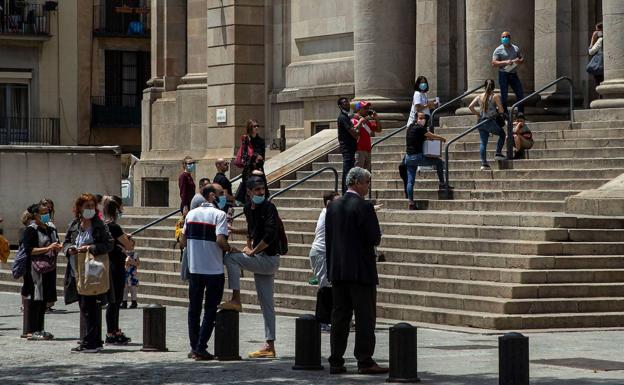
[188,273,225,353]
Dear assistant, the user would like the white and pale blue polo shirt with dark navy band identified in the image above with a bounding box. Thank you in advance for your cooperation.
[182,203,228,275]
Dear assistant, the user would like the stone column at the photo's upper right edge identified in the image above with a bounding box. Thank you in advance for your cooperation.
[590,0,624,108]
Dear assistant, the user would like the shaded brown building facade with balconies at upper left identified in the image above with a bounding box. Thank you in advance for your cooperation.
[0,0,151,154]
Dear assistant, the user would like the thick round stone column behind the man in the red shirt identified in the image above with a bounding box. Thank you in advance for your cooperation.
[353,0,416,117]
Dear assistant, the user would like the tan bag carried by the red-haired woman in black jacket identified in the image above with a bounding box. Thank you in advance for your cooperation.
[76,252,110,296]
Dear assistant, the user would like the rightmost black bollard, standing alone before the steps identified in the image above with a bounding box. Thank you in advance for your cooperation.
[498,333,529,385]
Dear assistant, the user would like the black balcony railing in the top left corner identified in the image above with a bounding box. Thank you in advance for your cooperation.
[0,4,50,36]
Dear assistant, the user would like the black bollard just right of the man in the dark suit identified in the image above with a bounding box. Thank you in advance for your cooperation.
[386,322,420,382]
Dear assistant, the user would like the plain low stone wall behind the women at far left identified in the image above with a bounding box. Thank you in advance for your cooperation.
[0,146,121,244]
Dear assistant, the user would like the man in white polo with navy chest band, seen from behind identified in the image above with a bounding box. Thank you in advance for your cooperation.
[181,185,235,361]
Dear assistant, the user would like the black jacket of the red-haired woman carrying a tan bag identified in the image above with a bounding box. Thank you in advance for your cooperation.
[63,217,115,305]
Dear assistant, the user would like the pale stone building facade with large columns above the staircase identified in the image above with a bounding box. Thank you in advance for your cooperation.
[134,0,624,206]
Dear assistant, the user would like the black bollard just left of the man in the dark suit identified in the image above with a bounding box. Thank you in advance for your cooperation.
[293,314,323,370]
